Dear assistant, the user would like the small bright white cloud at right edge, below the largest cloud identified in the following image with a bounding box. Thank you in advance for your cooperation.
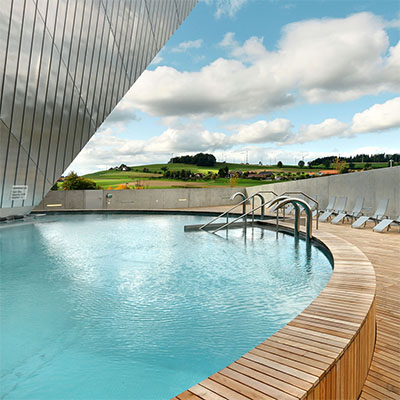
[351,97,400,133]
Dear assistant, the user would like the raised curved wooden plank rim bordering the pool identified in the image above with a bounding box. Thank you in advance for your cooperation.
[174,232,376,400]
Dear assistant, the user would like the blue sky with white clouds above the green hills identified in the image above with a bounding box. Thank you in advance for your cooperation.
[66,0,400,174]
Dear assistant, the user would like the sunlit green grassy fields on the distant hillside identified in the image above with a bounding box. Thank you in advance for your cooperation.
[80,163,387,189]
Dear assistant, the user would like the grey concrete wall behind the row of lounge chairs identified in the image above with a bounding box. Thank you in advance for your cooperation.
[247,166,400,218]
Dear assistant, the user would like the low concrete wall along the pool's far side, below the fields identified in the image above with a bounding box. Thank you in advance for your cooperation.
[35,188,246,211]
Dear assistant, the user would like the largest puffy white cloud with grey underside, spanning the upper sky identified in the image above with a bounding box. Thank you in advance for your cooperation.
[124,13,400,119]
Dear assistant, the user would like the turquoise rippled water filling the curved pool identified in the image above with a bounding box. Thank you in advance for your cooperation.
[0,215,332,400]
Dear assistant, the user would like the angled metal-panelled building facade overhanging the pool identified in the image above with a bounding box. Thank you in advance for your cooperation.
[0,0,197,216]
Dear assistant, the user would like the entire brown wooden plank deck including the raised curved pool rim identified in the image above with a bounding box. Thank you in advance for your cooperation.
[175,214,400,400]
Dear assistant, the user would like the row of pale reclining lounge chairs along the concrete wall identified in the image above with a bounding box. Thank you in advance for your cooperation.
[318,196,400,232]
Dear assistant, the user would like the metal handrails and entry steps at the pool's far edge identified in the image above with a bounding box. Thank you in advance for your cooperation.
[185,190,319,239]
